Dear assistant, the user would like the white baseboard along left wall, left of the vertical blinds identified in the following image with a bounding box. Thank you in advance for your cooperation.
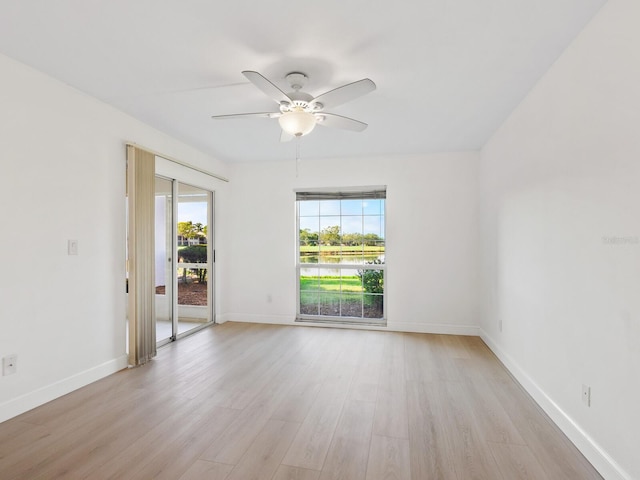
[0,355,127,422]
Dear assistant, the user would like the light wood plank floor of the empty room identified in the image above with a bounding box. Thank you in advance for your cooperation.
[0,323,601,480]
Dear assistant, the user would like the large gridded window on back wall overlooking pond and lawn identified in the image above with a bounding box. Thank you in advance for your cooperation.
[296,187,386,324]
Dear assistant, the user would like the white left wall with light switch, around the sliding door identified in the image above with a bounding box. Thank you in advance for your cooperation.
[0,50,226,421]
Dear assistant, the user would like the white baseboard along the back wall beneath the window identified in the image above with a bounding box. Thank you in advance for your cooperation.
[217,313,480,337]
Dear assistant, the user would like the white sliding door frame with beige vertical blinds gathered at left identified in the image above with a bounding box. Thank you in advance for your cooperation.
[125,142,229,360]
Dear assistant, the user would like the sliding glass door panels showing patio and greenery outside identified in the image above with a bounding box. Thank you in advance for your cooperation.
[155,176,214,345]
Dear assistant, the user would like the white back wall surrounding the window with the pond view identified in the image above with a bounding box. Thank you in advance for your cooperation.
[225,153,478,334]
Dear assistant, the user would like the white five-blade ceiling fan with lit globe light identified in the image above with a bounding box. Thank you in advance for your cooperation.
[211,70,376,142]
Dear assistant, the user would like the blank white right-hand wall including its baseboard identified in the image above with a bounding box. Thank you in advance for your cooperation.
[480,0,640,479]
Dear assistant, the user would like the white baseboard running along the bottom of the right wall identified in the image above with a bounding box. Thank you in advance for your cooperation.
[479,329,633,480]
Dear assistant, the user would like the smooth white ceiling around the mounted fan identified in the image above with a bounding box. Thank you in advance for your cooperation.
[0,0,605,161]
